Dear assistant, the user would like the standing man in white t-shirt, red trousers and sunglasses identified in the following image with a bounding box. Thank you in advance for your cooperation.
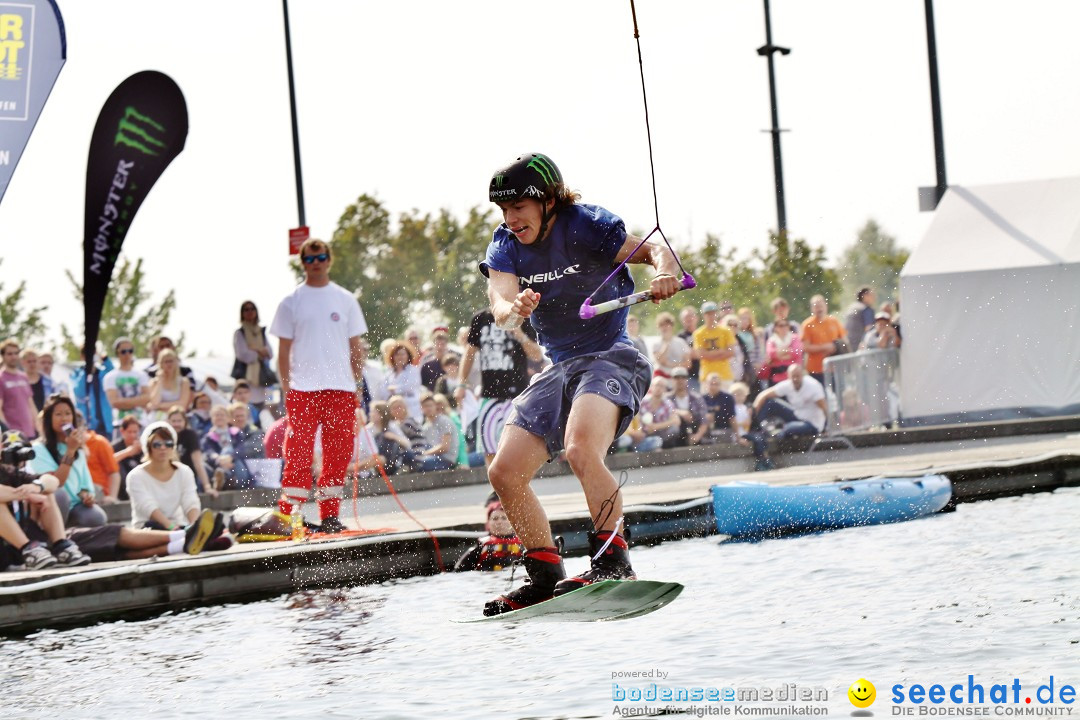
[270,240,367,532]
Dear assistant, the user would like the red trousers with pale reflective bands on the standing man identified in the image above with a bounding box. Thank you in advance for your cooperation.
[281,390,356,519]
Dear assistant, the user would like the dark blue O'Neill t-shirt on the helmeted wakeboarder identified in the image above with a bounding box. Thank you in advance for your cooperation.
[480,205,634,363]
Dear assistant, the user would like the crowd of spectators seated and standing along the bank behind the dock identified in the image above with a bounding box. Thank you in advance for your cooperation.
[0,288,901,525]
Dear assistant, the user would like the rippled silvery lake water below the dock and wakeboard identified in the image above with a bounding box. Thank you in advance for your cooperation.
[0,488,1080,720]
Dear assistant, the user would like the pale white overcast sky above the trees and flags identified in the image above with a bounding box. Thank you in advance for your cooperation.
[0,0,1080,355]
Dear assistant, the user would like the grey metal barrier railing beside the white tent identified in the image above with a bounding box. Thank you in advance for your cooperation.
[823,350,900,437]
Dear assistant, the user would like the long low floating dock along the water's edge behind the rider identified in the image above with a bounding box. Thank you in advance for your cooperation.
[0,432,1080,635]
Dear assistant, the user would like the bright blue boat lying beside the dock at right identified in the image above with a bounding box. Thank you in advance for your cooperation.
[712,475,953,538]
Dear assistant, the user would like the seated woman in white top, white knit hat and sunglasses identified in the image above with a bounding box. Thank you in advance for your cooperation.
[127,422,225,535]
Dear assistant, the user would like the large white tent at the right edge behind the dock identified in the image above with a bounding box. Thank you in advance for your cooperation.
[900,177,1080,424]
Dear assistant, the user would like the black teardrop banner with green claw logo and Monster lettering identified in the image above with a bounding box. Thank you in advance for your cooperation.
[82,70,188,399]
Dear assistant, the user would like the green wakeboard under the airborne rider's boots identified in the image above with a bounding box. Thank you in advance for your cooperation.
[455,580,683,623]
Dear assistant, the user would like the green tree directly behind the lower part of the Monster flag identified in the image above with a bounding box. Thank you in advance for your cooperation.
[60,258,184,361]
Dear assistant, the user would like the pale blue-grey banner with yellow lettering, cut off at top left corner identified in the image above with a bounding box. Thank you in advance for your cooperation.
[0,0,67,201]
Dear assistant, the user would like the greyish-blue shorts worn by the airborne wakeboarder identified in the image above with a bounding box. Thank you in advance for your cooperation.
[507,344,652,458]
